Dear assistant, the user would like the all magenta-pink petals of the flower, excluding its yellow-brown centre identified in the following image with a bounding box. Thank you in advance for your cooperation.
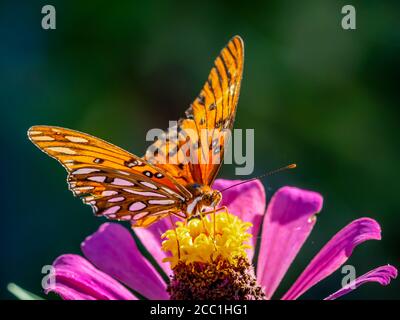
[47,179,397,300]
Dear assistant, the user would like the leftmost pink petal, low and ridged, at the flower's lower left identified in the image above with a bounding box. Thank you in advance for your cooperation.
[46,254,137,300]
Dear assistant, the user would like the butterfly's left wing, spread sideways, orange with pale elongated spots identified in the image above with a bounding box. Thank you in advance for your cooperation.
[28,126,191,226]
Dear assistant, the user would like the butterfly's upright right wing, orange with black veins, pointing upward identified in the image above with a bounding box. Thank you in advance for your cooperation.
[144,36,244,185]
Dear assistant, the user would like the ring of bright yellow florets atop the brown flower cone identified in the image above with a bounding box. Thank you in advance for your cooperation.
[162,212,252,268]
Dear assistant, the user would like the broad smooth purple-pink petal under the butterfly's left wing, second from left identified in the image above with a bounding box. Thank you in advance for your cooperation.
[82,223,169,299]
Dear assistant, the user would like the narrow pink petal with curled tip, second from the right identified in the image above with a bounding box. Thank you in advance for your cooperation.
[282,218,381,300]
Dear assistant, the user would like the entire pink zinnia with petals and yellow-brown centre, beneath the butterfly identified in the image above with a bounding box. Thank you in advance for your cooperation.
[46,180,397,300]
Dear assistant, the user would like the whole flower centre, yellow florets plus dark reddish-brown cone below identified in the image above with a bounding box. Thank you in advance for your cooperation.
[162,209,265,300]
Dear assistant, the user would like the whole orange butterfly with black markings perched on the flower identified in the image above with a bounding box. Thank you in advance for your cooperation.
[28,36,244,227]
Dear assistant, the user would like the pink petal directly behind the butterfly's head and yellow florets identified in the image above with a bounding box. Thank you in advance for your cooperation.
[213,179,266,260]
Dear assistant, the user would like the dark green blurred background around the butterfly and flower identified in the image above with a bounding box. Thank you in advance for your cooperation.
[0,0,400,299]
